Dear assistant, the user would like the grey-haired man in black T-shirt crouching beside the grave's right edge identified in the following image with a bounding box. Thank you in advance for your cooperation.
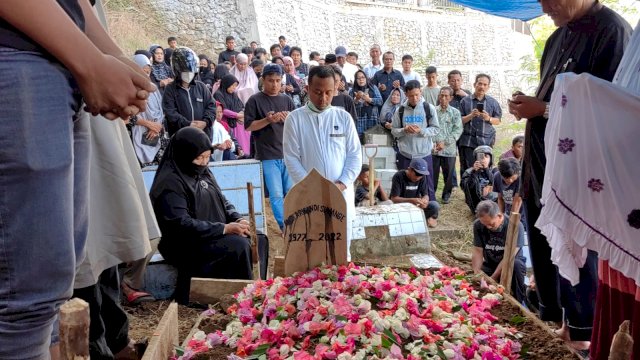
[471,200,527,303]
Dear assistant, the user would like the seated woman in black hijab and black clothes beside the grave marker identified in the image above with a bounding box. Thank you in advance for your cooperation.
[150,127,269,304]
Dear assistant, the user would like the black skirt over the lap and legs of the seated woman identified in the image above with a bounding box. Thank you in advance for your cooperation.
[173,234,269,305]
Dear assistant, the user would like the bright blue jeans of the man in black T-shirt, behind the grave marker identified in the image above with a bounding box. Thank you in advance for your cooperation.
[262,159,293,229]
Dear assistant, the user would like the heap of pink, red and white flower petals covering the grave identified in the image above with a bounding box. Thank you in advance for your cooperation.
[178,264,521,360]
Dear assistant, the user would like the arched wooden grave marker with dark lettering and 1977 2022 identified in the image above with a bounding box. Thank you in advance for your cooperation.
[284,169,347,275]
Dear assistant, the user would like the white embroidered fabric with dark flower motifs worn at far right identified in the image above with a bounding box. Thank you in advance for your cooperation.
[536,72,640,285]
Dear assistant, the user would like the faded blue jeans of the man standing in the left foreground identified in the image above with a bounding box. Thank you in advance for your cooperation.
[0,48,90,359]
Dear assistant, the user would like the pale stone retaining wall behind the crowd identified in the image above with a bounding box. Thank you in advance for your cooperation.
[154,0,533,104]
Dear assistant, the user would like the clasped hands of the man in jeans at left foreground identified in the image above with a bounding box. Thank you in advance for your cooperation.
[79,55,156,120]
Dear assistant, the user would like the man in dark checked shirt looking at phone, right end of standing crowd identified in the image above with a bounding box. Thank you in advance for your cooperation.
[459,74,502,169]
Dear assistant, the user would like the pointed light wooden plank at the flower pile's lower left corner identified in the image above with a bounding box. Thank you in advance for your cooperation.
[142,303,180,360]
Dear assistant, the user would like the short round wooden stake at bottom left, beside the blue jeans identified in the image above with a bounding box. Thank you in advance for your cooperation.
[60,298,90,360]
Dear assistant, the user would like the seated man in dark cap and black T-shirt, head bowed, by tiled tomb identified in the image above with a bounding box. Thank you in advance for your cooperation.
[390,158,440,228]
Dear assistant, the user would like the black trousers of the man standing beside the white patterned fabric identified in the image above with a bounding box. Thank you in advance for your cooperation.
[525,197,598,341]
